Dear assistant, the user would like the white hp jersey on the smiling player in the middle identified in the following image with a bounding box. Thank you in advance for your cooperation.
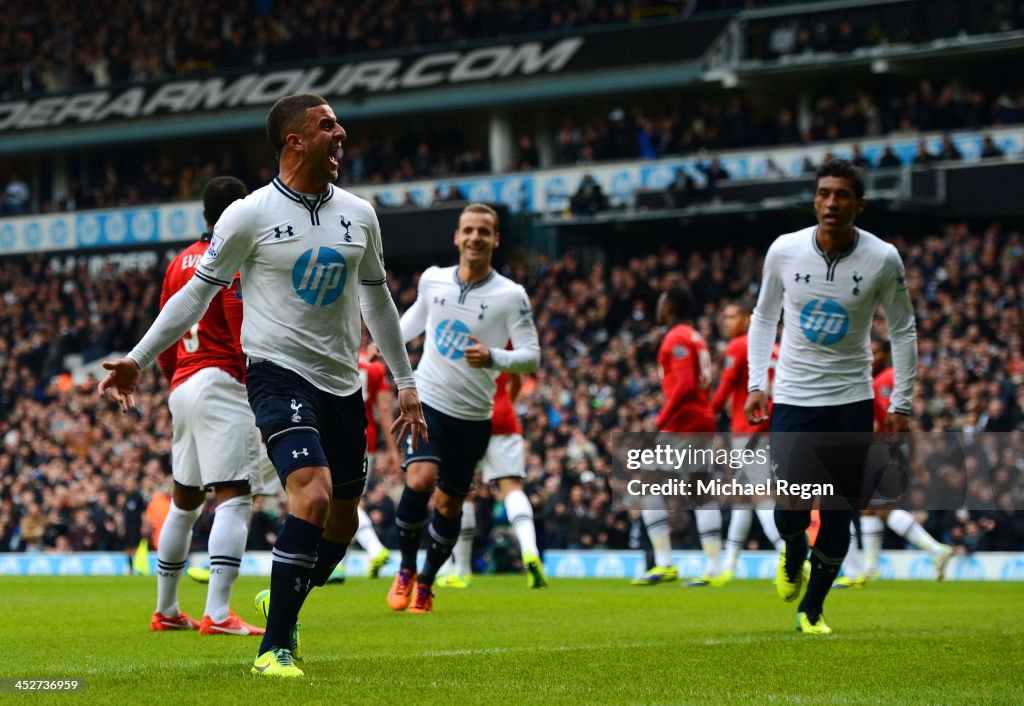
[401,265,541,420]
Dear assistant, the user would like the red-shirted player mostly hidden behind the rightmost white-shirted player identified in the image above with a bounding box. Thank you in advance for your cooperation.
[834,338,953,588]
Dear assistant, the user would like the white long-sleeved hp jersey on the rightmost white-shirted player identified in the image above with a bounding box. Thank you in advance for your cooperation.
[748,226,918,414]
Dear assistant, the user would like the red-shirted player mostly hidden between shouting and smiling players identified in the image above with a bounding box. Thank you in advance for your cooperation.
[328,343,399,583]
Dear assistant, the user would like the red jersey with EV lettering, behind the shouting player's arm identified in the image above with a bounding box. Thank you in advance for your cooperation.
[157,241,246,389]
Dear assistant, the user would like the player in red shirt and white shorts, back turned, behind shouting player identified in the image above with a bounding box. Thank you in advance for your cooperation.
[150,176,263,635]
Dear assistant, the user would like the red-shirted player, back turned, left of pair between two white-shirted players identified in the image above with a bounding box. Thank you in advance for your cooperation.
[633,286,722,586]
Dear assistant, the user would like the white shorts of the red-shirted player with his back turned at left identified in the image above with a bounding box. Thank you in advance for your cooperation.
[167,368,261,493]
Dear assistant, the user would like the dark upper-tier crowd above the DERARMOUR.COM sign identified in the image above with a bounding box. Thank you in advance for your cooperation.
[0,0,672,99]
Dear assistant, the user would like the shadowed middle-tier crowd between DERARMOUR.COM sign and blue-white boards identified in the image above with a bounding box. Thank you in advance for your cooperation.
[0,73,1024,215]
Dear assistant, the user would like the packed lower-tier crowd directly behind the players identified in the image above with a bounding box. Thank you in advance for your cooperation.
[0,222,1024,551]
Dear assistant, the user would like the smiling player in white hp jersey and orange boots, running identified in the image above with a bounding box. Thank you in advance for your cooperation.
[387,204,541,613]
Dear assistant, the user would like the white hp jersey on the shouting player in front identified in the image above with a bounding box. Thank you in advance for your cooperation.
[196,178,386,396]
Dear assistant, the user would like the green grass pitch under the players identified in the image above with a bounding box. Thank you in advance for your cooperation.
[0,576,1024,705]
